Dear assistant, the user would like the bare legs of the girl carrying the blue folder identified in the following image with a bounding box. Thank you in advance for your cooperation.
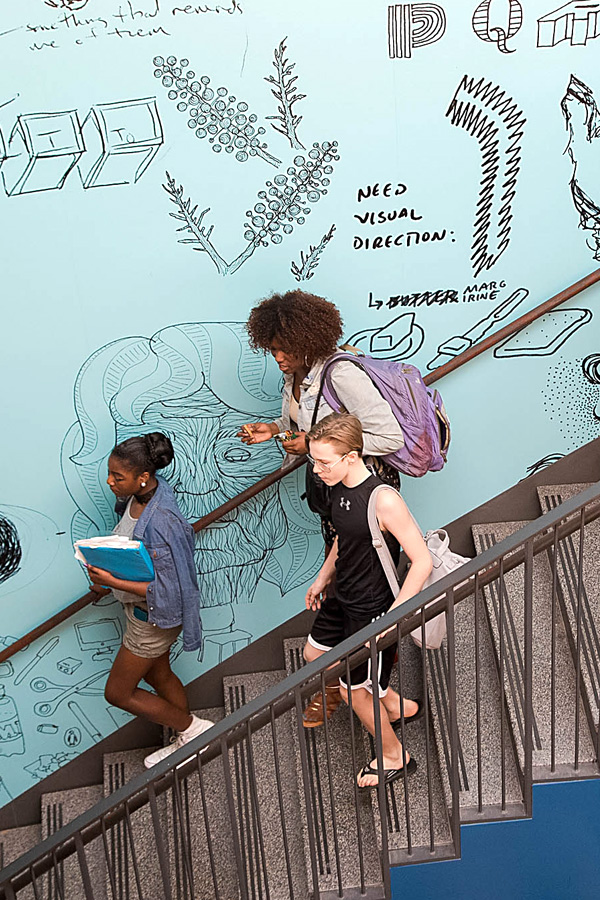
[104,647,192,731]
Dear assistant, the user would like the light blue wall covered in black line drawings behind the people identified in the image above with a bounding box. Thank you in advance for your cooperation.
[0,0,600,803]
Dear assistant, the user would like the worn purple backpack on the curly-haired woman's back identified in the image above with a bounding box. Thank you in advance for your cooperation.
[315,353,450,478]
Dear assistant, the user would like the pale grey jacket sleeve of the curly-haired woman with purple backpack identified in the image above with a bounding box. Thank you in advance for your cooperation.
[331,360,404,456]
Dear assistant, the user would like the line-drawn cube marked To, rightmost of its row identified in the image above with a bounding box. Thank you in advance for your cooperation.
[78,97,164,190]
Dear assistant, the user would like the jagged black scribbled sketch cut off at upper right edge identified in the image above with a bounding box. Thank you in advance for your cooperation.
[560,75,600,260]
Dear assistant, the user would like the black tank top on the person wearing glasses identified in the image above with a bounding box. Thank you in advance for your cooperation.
[331,475,400,618]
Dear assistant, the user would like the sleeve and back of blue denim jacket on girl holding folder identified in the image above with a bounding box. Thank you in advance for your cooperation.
[147,514,202,650]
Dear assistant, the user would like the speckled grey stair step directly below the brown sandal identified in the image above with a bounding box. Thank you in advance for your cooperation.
[284,638,382,896]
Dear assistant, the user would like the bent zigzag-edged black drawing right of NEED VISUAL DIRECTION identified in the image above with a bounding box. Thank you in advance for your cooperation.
[446,75,526,276]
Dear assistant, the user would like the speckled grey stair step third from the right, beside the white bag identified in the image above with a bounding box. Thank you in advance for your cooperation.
[427,597,523,822]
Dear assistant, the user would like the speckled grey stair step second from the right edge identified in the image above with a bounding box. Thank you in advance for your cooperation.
[473,522,595,769]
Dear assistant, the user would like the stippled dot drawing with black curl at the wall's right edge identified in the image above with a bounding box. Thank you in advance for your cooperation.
[543,353,600,452]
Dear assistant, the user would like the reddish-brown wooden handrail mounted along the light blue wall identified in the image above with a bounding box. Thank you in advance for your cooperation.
[0,269,600,663]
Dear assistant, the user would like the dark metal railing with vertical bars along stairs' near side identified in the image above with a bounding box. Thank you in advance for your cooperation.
[0,483,600,900]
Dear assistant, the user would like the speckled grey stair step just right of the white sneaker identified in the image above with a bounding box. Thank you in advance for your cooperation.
[223,671,309,900]
